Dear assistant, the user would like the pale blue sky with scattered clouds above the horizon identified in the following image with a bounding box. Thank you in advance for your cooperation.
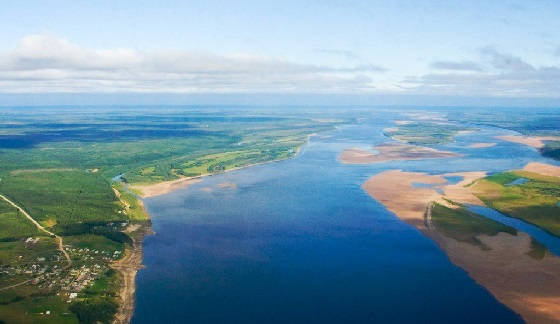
[0,0,560,104]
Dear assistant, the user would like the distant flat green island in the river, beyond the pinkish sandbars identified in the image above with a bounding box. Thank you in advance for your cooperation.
[384,121,472,145]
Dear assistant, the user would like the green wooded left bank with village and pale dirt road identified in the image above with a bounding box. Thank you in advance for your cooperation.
[0,107,350,323]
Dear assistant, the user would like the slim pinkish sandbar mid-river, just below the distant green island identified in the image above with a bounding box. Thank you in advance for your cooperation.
[339,143,462,164]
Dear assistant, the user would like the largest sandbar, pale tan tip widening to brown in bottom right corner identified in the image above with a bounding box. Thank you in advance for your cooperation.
[363,170,560,323]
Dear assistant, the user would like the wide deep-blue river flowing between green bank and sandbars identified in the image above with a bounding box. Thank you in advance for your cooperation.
[132,113,551,323]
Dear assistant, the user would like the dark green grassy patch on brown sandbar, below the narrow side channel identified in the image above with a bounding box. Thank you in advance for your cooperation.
[432,203,517,249]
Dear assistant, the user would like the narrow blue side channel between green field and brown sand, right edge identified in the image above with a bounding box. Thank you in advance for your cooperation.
[468,206,560,256]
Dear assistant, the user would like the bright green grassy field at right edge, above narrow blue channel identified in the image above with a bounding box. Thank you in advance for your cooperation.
[473,171,560,236]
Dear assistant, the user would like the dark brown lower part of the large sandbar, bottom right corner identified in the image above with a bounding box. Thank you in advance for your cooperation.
[438,232,560,323]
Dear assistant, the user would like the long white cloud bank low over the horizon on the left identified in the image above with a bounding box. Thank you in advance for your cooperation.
[0,35,384,93]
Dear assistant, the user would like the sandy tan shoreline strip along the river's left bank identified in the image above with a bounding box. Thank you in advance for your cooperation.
[111,133,317,324]
